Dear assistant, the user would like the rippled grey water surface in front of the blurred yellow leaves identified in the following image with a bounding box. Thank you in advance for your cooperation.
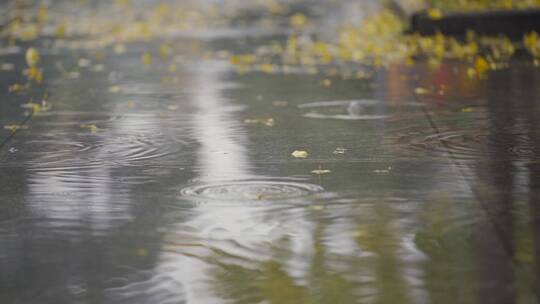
[0,0,540,303]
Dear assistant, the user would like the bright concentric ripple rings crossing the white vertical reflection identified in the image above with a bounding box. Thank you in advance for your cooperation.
[180,180,324,201]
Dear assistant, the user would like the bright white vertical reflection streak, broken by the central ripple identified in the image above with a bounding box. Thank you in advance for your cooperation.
[161,63,320,303]
